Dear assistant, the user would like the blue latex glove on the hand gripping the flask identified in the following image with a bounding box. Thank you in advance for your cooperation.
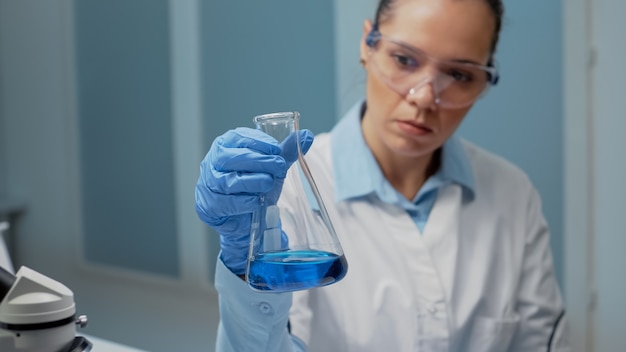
[196,127,313,275]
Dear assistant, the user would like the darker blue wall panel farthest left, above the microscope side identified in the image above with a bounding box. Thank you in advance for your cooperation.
[75,0,179,276]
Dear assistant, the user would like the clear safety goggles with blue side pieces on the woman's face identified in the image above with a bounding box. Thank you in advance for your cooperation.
[366,26,499,108]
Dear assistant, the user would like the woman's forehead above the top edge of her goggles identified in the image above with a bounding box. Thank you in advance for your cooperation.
[380,0,495,63]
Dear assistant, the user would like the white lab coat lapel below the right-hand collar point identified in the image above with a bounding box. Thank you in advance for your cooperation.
[423,184,463,300]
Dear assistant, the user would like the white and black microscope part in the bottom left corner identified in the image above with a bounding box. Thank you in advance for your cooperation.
[0,266,92,352]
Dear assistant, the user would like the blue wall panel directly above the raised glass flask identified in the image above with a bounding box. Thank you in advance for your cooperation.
[201,0,336,140]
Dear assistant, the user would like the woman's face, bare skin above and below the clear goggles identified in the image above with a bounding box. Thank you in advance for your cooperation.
[361,0,495,158]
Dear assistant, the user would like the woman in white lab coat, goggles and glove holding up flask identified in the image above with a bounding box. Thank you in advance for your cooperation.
[196,0,569,352]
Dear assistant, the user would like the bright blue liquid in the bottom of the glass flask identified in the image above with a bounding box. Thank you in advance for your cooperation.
[248,251,348,292]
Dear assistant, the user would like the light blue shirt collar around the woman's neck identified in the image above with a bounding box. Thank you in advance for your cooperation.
[331,102,474,203]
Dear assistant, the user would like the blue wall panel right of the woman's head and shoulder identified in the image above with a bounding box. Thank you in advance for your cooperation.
[459,0,564,287]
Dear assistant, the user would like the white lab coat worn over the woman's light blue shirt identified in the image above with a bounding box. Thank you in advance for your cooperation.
[279,134,569,352]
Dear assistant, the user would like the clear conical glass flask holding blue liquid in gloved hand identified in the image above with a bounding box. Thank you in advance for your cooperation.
[246,112,348,292]
